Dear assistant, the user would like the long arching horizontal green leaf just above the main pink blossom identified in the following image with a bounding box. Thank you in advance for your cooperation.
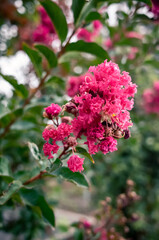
[66,40,110,60]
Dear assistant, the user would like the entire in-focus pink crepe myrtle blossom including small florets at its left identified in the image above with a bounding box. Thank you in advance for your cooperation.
[43,60,137,172]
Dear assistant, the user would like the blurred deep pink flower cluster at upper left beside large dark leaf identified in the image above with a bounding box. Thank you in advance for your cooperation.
[32,6,57,45]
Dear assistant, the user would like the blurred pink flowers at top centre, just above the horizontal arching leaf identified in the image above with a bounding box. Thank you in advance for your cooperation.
[77,20,103,42]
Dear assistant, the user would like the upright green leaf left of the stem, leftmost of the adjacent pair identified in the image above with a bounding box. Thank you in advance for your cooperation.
[23,43,42,77]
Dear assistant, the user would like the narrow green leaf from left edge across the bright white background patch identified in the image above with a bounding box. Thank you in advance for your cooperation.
[0,73,28,98]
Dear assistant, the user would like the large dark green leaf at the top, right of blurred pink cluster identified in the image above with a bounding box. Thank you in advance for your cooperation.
[40,0,68,42]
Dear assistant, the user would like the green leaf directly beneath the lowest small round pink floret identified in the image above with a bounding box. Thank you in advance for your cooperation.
[52,167,89,187]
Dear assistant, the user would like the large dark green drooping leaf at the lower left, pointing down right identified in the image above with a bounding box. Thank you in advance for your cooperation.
[20,188,55,227]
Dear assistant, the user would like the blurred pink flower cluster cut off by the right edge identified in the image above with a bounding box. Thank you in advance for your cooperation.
[143,81,159,114]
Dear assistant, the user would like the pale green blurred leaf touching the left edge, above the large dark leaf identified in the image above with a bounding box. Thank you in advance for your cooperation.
[0,180,22,205]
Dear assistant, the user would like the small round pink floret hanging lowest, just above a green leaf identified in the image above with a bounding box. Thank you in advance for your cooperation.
[67,155,84,172]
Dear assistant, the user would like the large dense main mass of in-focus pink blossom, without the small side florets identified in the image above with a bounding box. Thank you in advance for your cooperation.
[72,60,136,154]
